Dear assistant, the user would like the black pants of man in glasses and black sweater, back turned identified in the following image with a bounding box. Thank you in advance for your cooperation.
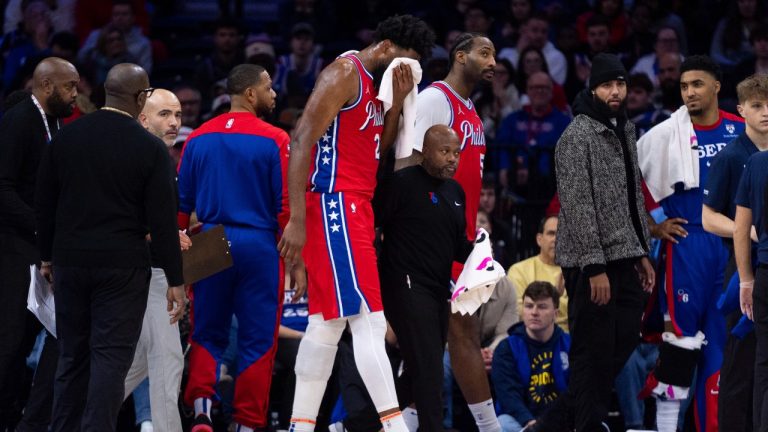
[51,266,151,432]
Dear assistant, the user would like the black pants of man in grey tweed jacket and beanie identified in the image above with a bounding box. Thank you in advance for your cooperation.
[541,260,644,432]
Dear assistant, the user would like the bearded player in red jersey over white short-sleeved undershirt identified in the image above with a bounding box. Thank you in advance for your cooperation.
[408,33,501,432]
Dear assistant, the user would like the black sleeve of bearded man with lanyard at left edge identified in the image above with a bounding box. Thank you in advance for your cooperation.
[0,109,35,234]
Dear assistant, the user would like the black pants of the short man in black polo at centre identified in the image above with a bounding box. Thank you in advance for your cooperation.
[381,283,450,432]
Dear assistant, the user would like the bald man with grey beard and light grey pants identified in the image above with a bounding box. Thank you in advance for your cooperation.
[125,89,192,432]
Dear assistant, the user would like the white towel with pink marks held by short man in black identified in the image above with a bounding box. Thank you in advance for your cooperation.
[451,228,506,315]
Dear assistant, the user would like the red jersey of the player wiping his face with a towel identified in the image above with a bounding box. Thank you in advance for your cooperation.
[309,55,384,199]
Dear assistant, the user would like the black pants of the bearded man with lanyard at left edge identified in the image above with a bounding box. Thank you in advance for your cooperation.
[0,233,42,430]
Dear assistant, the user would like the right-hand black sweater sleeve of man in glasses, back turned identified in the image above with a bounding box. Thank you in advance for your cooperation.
[144,143,184,286]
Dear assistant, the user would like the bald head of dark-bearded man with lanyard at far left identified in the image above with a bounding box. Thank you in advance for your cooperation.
[32,57,80,118]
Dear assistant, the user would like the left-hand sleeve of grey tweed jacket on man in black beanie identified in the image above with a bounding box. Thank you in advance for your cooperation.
[555,124,605,268]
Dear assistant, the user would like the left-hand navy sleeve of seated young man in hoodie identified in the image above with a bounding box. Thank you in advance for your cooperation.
[491,342,534,425]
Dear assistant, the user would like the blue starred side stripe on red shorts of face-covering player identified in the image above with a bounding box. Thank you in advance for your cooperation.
[320,193,370,316]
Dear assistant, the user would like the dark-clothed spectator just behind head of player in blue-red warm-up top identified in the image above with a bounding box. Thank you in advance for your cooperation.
[195,19,244,106]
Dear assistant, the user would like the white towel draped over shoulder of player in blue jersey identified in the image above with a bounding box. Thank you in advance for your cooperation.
[637,105,699,202]
